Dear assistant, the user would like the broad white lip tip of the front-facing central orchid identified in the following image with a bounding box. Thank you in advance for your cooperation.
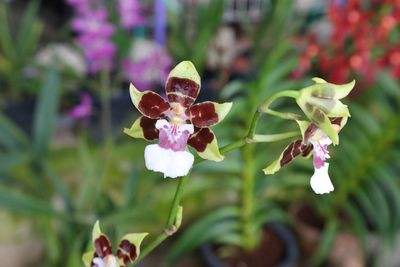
[144,144,194,178]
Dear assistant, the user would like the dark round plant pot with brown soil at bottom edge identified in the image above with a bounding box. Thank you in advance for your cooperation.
[200,223,299,267]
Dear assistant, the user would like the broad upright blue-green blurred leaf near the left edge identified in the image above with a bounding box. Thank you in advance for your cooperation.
[33,68,60,159]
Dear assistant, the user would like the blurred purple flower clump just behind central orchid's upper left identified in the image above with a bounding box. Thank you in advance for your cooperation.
[122,42,172,90]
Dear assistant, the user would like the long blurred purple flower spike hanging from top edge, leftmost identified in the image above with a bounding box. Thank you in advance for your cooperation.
[67,0,116,74]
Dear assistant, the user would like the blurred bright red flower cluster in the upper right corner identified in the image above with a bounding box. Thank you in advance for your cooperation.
[293,0,400,91]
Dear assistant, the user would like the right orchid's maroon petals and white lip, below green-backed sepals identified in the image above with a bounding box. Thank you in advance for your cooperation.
[263,117,347,194]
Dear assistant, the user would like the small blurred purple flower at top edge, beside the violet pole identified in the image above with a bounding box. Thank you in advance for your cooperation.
[118,0,145,29]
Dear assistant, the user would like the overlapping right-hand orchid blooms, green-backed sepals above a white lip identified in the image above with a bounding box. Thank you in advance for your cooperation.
[263,78,354,194]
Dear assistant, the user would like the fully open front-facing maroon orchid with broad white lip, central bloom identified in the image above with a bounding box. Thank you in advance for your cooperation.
[124,61,232,178]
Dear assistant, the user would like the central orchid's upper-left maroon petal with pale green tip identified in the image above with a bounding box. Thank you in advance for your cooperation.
[129,84,170,119]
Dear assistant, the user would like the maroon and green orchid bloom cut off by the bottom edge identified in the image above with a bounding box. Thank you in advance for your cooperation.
[83,222,147,267]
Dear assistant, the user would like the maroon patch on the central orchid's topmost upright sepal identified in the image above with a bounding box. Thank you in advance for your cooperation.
[165,77,200,108]
